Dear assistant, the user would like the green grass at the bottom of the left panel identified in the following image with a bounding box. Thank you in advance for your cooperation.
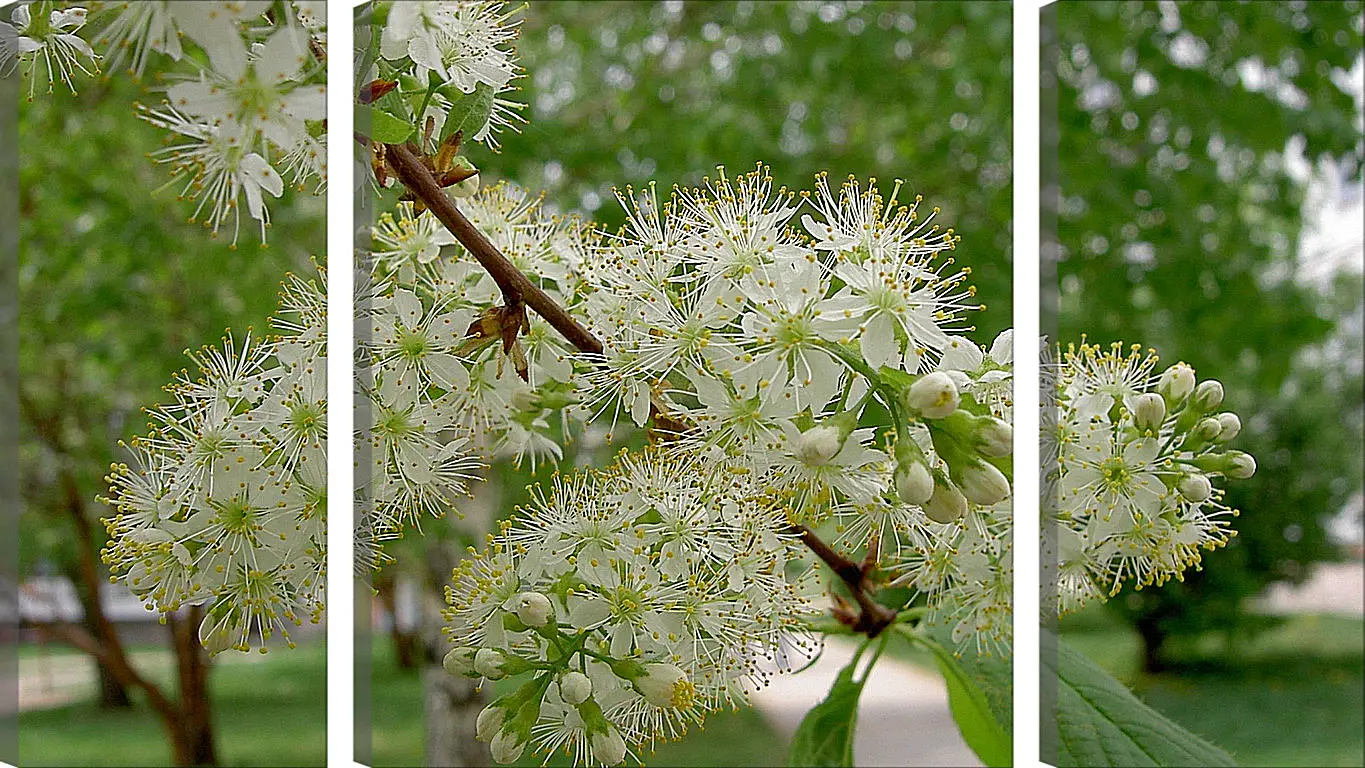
[19,644,326,765]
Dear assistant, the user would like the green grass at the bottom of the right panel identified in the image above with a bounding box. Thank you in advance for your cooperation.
[1062,610,1365,767]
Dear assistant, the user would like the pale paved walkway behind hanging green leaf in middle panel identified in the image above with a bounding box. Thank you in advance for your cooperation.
[753,638,981,768]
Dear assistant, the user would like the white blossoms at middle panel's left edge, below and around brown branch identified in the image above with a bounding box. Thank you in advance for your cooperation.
[356,184,580,574]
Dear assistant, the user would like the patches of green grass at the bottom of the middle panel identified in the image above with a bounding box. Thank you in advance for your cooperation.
[373,640,786,768]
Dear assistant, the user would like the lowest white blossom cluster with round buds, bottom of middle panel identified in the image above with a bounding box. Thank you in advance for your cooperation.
[444,452,818,765]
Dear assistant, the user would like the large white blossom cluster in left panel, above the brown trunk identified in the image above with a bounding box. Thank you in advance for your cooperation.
[104,266,326,652]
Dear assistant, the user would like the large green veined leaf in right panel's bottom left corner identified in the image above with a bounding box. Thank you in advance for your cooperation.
[1040,632,1237,768]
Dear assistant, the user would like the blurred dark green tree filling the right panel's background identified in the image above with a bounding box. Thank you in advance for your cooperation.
[1058,1,1365,670]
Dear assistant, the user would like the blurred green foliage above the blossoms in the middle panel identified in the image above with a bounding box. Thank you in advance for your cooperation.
[483,1,1013,341]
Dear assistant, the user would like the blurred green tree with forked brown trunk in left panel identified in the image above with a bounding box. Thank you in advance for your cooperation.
[18,72,325,761]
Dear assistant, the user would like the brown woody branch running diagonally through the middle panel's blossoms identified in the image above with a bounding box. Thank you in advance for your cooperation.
[382,142,897,637]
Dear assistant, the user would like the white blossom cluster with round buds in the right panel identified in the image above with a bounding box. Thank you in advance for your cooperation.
[1043,342,1256,612]
